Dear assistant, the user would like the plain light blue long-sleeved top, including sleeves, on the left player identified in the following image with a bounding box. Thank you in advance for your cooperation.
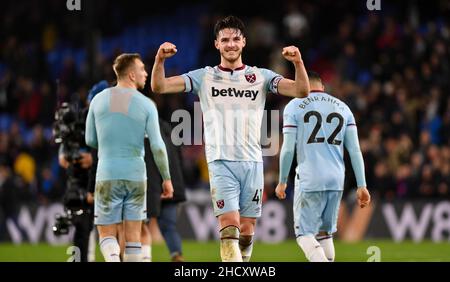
[86,87,170,181]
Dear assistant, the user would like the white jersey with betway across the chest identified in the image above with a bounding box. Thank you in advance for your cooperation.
[182,65,283,162]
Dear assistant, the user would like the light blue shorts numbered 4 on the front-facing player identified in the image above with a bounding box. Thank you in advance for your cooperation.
[208,160,264,218]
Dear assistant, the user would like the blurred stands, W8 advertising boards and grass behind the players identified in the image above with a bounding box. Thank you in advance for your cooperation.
[0,0,450,261]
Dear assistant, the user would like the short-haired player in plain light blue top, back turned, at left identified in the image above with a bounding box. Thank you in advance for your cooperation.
[86,54,173,262]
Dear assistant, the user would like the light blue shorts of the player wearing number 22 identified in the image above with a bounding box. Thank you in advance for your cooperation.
[294,179,342,237]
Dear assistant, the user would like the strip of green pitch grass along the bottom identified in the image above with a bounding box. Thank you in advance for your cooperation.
[0,240,450,262]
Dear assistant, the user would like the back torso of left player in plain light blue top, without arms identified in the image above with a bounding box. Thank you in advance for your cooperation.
[90,87,154,181]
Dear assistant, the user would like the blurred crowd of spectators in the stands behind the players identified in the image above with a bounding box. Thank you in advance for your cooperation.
[0,1,450,220]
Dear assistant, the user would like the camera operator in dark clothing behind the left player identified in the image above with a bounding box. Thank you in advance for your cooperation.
[54,97,94,262]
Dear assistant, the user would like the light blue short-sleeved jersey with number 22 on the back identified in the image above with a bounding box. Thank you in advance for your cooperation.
[285,92,355,191]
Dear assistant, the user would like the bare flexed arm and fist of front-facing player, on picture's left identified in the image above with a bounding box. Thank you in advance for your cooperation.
[151,42,186,94]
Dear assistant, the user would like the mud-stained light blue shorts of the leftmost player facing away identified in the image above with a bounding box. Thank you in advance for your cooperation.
[94,180,147,225]
